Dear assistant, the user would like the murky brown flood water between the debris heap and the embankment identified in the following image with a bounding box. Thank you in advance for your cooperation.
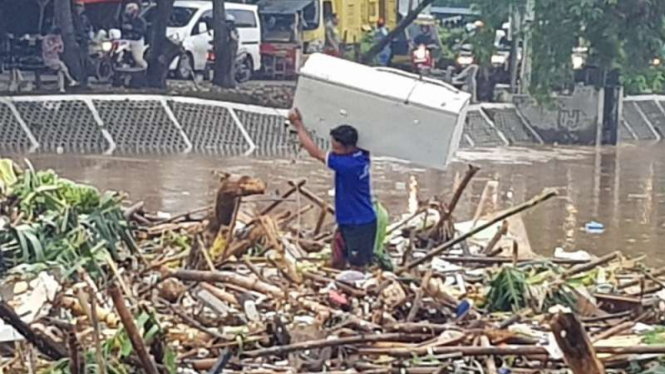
[13,144,665,266]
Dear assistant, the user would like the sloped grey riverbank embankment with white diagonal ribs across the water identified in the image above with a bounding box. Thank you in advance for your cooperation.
[0,89,665,156]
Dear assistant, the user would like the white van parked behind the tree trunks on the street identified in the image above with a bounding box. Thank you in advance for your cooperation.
[143,0,261,78]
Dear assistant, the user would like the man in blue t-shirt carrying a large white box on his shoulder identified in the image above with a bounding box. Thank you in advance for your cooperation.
[289,109,377,270]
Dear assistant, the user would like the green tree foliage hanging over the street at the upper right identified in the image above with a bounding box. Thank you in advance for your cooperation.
[435,0,665,96]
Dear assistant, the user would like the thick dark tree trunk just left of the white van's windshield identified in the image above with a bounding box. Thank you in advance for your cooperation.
[147,0,180,88]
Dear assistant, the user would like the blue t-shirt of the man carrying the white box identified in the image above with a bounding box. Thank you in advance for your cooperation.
[327,150,376,225]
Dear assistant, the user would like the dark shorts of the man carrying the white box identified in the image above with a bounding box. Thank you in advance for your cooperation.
[339,221,376,267]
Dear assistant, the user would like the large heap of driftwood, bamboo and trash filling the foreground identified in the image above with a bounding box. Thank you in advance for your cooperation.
[0,160,665,374]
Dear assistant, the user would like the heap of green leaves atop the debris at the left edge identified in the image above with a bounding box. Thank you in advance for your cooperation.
[0,160,136,277]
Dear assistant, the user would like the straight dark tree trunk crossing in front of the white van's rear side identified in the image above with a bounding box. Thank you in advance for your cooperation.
[212,0,235,88]
